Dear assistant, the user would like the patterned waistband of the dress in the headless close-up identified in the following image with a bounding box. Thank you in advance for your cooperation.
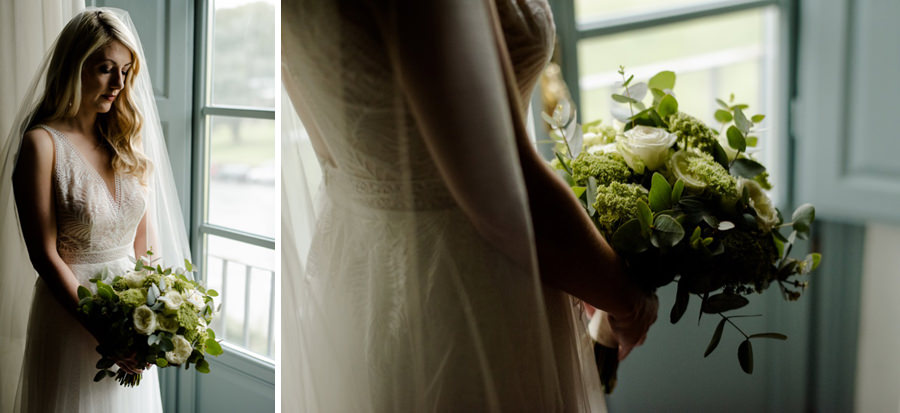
[322,166,456,211]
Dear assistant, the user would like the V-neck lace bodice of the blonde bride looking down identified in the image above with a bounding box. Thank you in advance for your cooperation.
[40,125,147,264]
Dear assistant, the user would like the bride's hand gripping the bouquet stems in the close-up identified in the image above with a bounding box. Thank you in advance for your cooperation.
[603,294,659,360]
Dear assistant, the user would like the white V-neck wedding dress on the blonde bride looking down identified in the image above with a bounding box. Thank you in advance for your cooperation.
[15,125,162,413]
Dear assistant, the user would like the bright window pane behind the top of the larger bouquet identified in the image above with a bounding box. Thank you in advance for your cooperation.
[578,9,773,124]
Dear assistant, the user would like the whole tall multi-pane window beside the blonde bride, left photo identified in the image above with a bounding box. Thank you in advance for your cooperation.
[192,0,278,362]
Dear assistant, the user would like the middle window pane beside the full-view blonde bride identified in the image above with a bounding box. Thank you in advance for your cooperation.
[207,116,277,237]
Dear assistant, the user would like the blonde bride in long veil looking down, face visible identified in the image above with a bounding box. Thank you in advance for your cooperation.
[0,9,188,412]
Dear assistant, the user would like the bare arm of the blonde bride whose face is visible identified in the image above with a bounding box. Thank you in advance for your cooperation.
[13,129,81,320]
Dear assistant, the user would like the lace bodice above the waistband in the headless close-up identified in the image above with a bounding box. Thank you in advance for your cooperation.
[283,0,555,210]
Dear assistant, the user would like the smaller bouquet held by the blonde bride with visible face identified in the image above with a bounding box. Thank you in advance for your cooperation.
[78,252,222,387]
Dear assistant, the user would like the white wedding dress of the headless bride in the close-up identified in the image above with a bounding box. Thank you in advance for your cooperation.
[281,0,605,412]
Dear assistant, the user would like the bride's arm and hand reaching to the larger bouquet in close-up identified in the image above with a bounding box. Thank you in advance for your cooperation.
[381,0,656,353]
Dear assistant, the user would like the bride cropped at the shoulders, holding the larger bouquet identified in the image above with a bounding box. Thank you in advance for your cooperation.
[281,0,656,412]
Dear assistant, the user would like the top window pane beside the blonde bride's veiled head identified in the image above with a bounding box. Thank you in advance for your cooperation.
[210,0,276,108]
